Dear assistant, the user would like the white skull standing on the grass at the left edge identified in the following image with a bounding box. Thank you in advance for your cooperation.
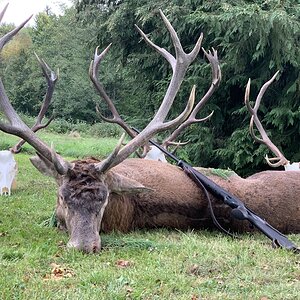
[0,150,17,196]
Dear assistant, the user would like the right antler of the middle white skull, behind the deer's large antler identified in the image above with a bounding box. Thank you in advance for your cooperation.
[162,48,222,147]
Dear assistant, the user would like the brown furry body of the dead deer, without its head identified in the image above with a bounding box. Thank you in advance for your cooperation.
[101,159,300,233]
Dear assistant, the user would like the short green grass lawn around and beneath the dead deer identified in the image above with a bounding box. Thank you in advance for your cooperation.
[0,133,300,300]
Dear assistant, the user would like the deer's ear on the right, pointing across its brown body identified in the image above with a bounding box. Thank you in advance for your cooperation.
[105,171,153,194]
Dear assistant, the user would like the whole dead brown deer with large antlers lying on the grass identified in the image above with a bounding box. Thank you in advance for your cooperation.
[0,5,300,253]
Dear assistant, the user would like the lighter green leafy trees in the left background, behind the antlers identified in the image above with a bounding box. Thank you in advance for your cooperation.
[2,8,98,122]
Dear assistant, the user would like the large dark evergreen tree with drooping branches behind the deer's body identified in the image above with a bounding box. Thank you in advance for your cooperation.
[77,0,300,174]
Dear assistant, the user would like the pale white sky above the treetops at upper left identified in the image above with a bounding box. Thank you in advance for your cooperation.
[0,0,72,25]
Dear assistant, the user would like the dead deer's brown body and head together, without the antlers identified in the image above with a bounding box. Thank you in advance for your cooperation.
[31,157,300,252]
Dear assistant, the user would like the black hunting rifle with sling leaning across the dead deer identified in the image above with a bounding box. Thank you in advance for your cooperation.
[132,128,300,253]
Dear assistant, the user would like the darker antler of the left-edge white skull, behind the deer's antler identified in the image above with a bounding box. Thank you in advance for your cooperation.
[10,53,59,153]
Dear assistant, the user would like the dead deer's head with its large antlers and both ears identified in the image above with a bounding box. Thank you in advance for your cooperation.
[0,8,209,252]
